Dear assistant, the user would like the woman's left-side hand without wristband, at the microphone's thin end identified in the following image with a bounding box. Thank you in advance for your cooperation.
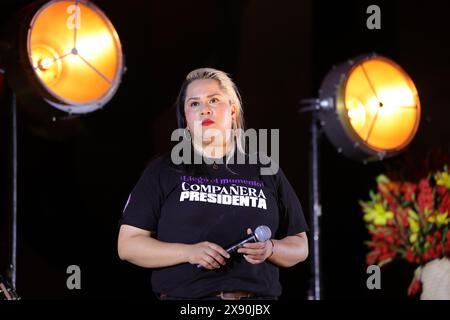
[187,241,230,270]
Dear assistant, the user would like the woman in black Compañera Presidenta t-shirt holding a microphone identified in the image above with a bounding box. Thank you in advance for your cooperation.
[118,68,308,299]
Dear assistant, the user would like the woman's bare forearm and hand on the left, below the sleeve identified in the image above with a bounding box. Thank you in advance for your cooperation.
[117,225,230,269]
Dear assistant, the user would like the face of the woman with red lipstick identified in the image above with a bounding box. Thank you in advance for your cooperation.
[184,79,236,145]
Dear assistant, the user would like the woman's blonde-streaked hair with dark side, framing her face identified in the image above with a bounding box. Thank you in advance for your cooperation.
[177,68,245,158]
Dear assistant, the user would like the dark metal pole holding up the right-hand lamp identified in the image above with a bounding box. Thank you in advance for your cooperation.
[308,111,322,300]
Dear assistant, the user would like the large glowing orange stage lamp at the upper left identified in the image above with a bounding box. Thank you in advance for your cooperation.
[4,0,124,117]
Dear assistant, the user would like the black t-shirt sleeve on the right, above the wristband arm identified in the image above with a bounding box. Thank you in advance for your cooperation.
[276,168,309,237]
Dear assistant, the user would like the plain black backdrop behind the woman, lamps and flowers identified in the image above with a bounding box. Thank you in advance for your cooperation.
[0,0,450,299]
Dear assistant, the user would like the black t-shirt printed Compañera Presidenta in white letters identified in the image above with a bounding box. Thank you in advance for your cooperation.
[121,152,308,299]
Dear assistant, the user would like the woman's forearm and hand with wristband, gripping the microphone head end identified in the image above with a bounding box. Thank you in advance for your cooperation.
[238,232,309,267]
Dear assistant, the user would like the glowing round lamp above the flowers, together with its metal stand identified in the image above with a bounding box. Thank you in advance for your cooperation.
[299,54,420,300]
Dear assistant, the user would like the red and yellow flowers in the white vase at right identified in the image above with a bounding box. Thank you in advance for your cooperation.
[360,166,450,295]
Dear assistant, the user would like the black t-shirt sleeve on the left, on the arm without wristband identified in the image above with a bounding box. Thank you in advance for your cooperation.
[120,165,163,232]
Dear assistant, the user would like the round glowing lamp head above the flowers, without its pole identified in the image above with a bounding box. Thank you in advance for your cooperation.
[319,55,420,161]
